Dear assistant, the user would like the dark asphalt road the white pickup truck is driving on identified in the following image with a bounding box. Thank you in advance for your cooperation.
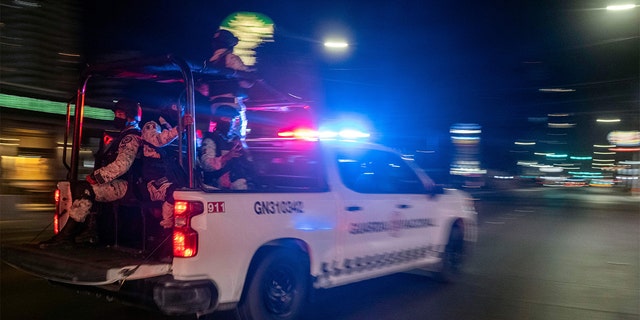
[0,188,640,320]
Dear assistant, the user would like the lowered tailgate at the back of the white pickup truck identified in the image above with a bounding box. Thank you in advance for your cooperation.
[2,244,171,286]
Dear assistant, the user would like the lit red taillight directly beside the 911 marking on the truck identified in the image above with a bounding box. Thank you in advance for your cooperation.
[173,201,204,258]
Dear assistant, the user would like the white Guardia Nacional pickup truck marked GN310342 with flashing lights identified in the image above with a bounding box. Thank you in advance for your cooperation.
[2,56,476,319]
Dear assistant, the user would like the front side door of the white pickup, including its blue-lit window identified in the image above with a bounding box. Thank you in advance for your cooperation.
[336,149,434,273]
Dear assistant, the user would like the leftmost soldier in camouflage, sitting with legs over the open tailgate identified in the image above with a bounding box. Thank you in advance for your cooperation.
[40,99,142,248]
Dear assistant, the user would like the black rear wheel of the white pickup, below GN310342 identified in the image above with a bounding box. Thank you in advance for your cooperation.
[238,248,309,320]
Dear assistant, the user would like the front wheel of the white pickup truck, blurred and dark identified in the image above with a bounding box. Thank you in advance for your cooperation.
[436,224,465,282]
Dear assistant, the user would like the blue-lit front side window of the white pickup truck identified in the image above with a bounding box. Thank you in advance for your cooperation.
[337,150,425,194]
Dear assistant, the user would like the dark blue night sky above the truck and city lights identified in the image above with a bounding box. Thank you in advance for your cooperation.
[2,0,640,170]
